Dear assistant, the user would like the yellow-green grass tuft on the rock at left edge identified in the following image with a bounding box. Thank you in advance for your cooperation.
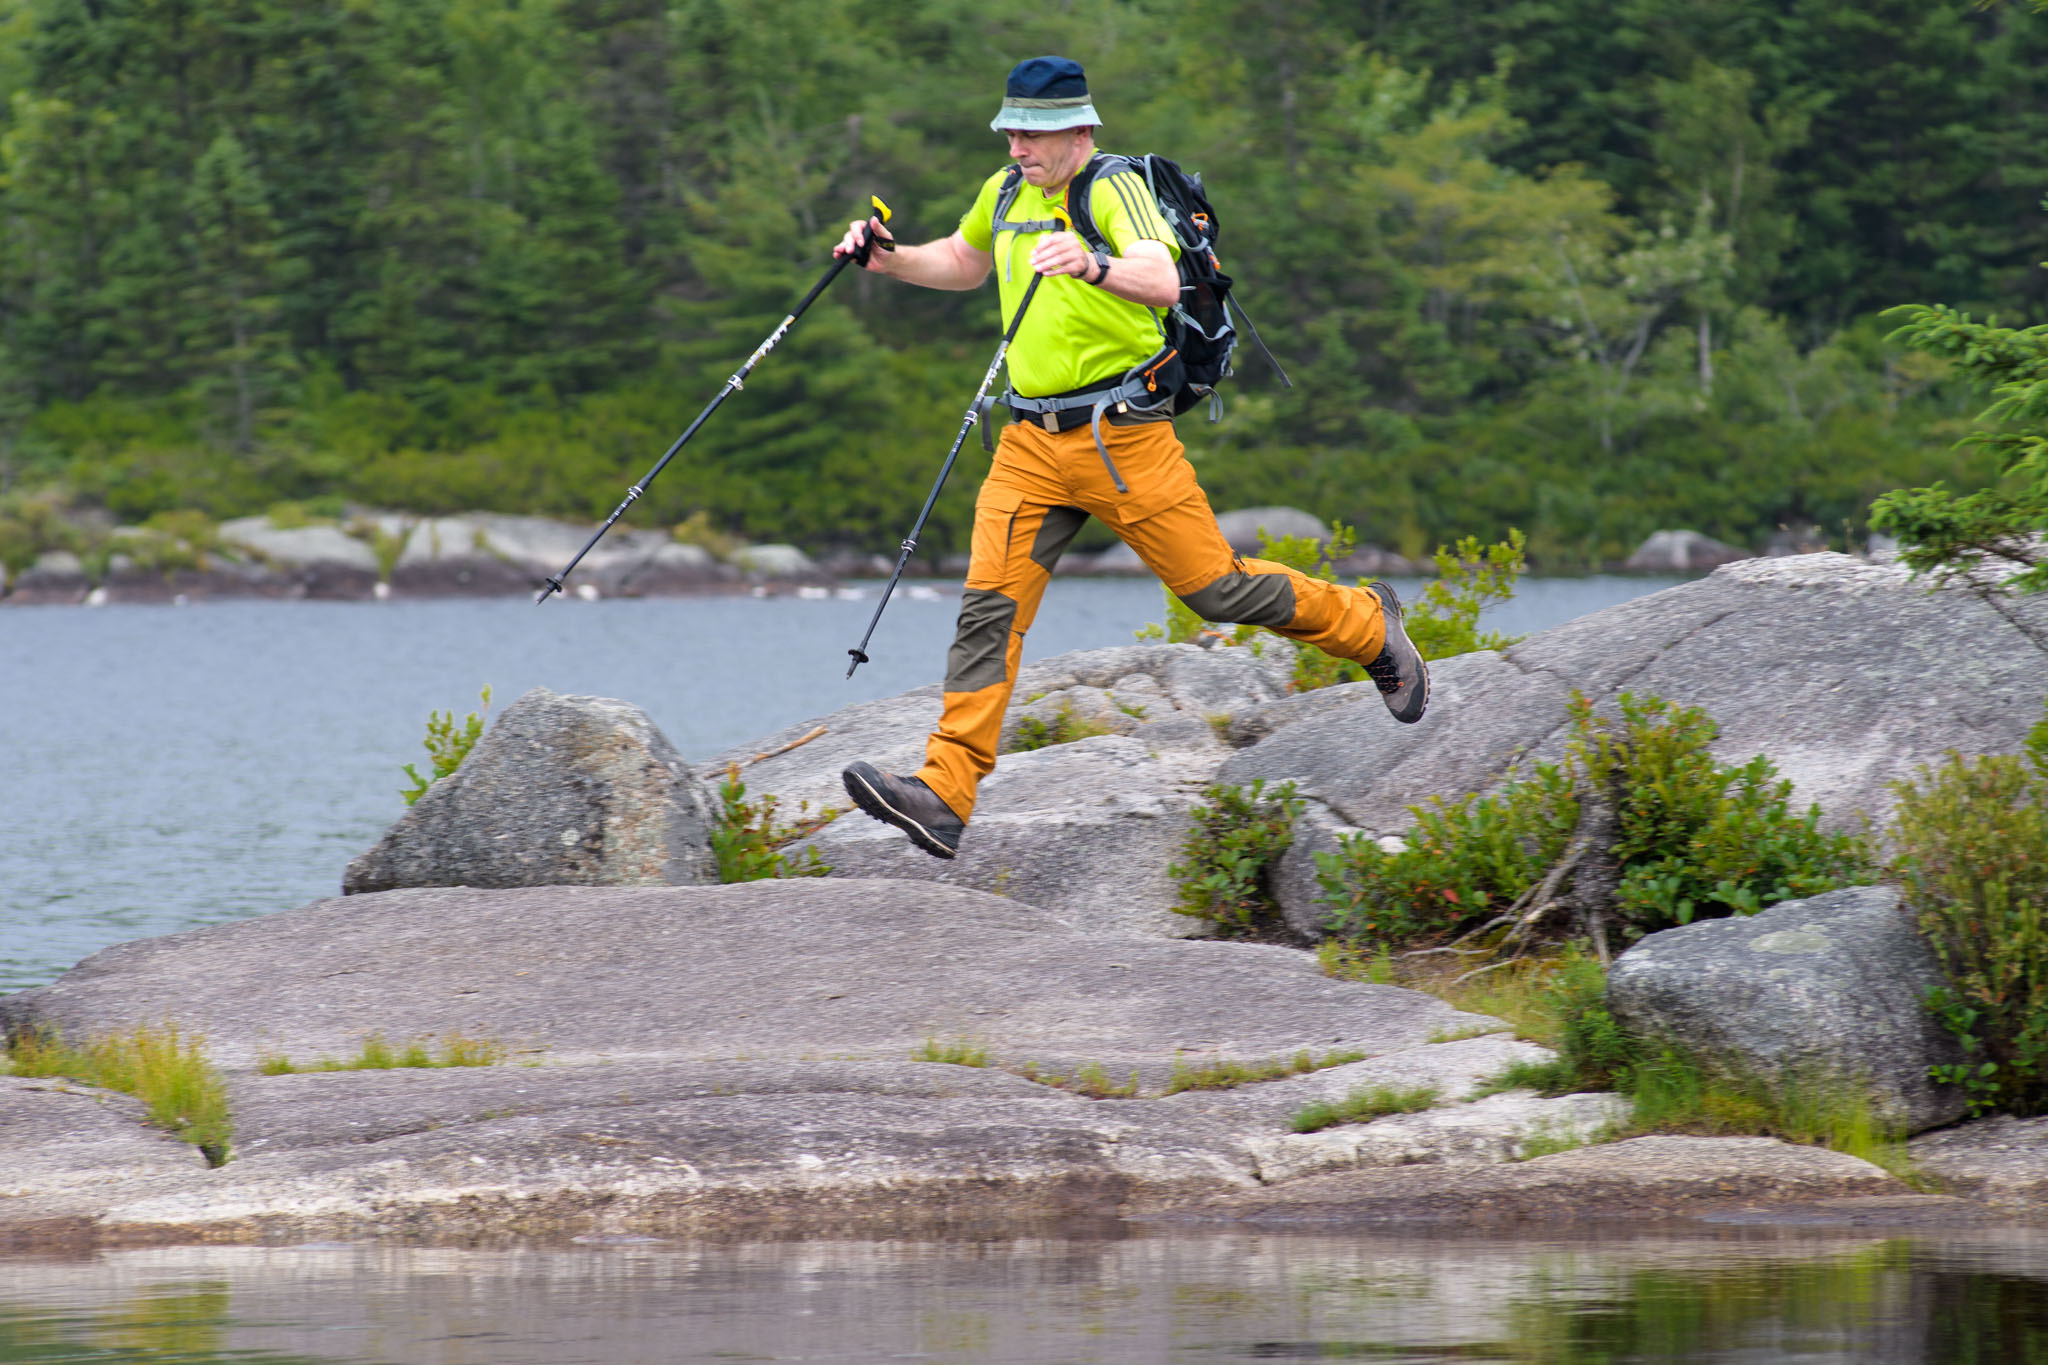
[6,1023,233,1166]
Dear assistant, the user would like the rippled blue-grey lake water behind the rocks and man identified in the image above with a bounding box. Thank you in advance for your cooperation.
[0,577,1675,990]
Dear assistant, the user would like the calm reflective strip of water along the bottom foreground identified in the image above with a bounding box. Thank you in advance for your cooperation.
[0,1228,2048,1365]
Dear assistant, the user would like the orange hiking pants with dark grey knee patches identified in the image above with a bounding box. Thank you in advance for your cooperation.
[918,422,1386,821]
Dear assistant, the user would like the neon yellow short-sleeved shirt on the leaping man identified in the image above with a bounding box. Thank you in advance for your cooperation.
[961,158,1180,397]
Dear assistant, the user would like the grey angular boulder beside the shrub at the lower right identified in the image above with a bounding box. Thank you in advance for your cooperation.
[1608,886,1966,1132]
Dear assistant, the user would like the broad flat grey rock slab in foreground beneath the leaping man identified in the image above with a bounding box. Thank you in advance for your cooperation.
[0,880,1540,1238]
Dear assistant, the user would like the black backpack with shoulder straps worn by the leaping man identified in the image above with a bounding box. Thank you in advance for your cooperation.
[993,153,1294,422]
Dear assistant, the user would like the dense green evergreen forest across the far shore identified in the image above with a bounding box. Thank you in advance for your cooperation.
[0,0,2048,569]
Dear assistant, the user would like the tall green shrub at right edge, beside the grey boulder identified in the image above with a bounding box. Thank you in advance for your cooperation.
[1892,720,2048,1113]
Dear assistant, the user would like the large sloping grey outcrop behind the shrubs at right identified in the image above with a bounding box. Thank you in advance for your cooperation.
[1219,555,2048,941]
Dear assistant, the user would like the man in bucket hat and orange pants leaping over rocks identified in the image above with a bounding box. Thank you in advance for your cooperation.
[834,57,1430,857]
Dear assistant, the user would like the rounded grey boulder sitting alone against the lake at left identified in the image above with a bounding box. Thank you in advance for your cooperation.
[342,688,717,894]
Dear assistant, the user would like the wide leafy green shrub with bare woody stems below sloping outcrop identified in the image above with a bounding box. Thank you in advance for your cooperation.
[1317,692,1870,943]
